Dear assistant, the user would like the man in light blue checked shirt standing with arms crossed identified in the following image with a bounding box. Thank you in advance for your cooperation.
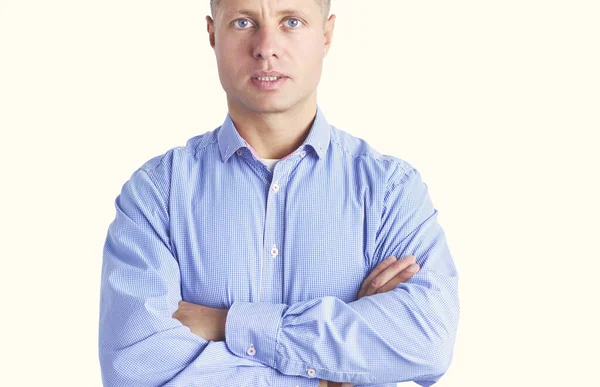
[99,0,459,387]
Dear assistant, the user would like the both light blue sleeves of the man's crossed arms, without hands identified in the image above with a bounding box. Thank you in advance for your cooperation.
[99,166,459,387]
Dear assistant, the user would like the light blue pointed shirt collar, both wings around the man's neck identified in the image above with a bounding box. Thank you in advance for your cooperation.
[217,106,331,162]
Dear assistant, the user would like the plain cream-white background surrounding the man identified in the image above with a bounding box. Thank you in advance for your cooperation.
[0,0,600,387]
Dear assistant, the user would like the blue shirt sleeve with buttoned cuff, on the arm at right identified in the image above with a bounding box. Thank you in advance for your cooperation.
[225,168,459,386]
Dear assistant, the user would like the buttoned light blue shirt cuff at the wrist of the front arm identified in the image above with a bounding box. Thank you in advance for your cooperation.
[225,302,288,369]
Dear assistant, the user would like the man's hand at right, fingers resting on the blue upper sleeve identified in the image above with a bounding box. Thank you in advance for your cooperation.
[319,255,420,387]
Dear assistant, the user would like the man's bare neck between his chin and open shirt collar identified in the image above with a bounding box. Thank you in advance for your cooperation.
[227,99,317,159]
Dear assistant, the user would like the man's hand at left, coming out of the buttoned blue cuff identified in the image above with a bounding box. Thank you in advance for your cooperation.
[173,301,229,341]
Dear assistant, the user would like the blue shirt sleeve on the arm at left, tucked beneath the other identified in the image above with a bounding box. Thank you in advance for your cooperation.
[99,169,318,387]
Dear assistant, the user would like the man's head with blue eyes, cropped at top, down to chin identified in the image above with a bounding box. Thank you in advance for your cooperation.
[206,0,335,113]
